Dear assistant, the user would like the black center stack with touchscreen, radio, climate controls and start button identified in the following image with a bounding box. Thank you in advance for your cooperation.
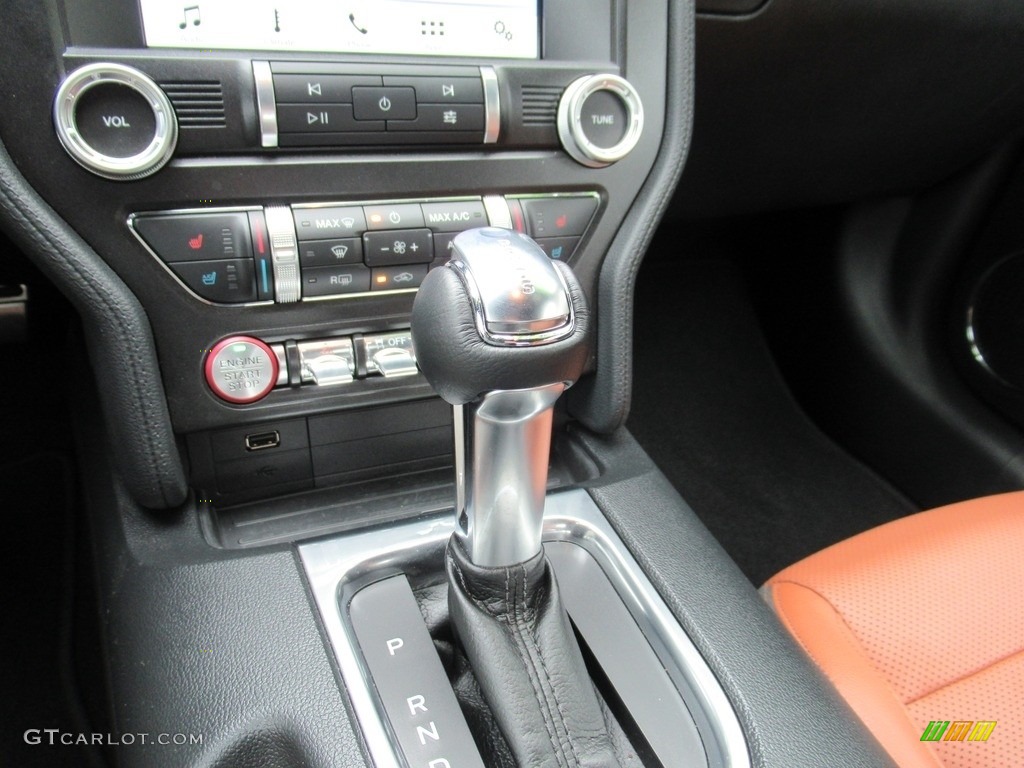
[25,0,678,515]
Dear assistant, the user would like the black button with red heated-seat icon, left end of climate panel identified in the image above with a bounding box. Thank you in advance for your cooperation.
[132,211,253,263]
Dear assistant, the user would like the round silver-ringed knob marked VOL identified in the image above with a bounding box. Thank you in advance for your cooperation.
[53,63,178,181]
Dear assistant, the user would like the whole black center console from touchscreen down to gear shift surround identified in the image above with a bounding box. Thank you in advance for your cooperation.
[0,0,897,768]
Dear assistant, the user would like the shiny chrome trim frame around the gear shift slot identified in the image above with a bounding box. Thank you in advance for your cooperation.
[298,489,751,768]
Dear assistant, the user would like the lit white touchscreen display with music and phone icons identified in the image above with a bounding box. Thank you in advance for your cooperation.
[139,0,540,58]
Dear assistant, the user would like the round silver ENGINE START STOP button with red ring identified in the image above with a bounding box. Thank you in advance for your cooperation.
[204,336,279,404]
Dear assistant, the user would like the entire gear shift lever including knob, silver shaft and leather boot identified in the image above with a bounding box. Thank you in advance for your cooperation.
[413,228,618,768]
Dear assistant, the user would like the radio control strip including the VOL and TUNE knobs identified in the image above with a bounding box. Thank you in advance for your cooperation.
[53,56,643,181]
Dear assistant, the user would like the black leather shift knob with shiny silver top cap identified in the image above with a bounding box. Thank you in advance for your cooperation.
[412,227,590,406]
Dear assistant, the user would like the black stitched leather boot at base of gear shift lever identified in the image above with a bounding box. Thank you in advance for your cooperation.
[445,537,618,768]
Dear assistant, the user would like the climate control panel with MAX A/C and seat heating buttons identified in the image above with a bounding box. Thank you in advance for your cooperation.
[128,193,600,306]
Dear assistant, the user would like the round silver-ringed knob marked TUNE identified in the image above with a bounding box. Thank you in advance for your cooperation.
[558,75,643,168]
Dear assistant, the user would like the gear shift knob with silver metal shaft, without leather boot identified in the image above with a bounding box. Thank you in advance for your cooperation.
[413,228,588,566]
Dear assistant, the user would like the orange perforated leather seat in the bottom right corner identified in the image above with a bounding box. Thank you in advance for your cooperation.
[762,492,1024,768]
